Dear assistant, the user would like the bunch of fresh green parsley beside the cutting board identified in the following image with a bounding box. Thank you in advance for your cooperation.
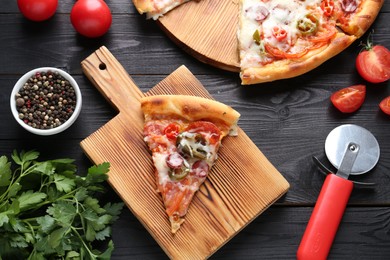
[0,151,123,259]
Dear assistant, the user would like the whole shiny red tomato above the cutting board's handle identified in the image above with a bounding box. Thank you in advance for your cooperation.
[70,0,112,38]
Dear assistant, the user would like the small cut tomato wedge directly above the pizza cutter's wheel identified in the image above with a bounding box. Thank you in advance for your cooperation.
[330,85,366,113]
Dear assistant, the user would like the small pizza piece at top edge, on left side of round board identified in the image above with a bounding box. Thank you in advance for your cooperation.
[133,0,194,20]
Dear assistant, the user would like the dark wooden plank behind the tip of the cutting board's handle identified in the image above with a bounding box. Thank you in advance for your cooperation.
[0,6,390,76]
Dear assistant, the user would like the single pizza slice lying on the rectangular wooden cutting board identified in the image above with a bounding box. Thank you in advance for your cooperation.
[141,95,240,233]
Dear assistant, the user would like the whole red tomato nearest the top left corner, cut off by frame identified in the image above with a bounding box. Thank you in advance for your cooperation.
[18,0,58,22]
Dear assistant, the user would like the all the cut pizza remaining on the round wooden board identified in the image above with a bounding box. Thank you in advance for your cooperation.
[133,0,384,85]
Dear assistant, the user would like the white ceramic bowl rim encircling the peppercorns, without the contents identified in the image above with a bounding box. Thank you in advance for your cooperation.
[10,67,82,135]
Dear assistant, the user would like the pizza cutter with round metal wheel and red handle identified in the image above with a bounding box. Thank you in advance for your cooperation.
[297,124,380,260]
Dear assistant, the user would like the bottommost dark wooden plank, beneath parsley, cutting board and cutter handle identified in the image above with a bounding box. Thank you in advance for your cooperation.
[108,206,390,260]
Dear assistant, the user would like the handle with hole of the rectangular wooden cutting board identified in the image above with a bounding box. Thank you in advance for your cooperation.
[81,46,143,112]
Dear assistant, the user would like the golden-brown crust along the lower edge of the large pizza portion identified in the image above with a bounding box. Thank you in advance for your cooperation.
[240,33,356,85]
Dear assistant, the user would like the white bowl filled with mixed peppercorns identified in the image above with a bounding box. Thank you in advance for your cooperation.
[10,67,82,135]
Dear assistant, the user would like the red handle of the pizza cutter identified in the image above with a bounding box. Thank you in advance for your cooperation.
[297,174,353,260]
